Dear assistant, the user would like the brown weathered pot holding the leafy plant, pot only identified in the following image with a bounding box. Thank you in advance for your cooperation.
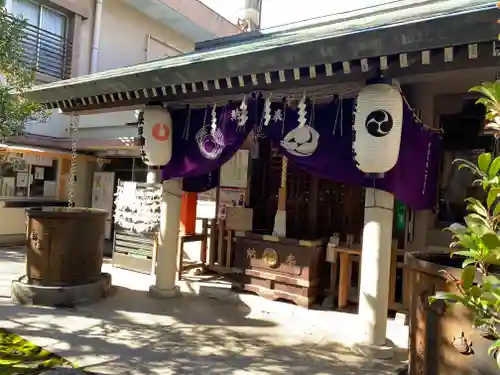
[405,251,500,375]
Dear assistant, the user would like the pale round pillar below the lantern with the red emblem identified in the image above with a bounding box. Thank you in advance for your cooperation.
[149,179,182,298]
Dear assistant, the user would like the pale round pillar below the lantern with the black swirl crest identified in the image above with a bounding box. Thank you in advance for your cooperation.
[358,188,394,357]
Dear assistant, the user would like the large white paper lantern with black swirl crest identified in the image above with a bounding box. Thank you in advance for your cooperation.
[353,83,403,174]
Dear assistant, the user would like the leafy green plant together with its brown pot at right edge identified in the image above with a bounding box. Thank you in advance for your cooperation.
[405,82,500,375]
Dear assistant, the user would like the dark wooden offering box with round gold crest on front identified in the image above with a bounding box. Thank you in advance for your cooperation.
[234,232,327,308]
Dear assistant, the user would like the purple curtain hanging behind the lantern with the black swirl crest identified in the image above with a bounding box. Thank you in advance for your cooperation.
[267,100,441,209]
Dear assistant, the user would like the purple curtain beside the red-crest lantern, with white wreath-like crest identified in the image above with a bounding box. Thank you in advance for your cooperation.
[162,100,259,182]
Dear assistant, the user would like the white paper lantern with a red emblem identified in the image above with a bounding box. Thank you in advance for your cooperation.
[143,106,172,166]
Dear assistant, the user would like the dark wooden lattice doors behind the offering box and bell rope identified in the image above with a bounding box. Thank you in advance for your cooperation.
[252,142,364,240]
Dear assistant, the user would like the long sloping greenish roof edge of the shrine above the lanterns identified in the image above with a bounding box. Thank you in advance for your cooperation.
[27,0,498,103]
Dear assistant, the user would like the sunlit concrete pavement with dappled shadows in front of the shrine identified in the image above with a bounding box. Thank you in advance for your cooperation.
[0,249,407,375]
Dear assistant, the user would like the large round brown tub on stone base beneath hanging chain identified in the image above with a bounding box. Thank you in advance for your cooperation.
[12,207,110,306]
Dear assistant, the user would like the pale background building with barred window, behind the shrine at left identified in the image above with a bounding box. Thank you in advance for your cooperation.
[0,0,240,205]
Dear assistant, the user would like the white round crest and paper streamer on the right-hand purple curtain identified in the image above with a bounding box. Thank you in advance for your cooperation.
[281,95,319,156]
